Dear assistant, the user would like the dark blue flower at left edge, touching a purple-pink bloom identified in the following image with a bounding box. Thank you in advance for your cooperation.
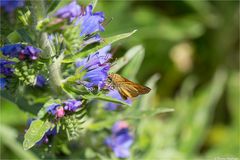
[0,44,24,58]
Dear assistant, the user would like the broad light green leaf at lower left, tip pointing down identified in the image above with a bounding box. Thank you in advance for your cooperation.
[23,120,52,150]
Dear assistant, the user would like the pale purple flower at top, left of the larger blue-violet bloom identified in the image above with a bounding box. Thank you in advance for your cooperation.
[55,1,81,21]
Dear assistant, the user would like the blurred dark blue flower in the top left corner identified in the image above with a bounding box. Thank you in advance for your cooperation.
[0,0,25,13]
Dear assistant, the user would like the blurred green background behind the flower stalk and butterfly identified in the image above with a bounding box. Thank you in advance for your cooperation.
[0,0,240,160]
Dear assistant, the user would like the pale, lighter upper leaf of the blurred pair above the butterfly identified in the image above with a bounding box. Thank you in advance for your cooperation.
[110,45,144,73]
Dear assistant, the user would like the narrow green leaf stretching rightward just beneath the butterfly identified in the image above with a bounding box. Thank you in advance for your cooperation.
[83,95,129,106]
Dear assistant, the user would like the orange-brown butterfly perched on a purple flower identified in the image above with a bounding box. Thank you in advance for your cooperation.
[108,73,151,100]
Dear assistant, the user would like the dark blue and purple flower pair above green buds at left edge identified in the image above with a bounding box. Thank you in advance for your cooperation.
[0,44,41,60]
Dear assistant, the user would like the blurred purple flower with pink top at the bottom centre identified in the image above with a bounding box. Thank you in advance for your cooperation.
[105,121,133,158]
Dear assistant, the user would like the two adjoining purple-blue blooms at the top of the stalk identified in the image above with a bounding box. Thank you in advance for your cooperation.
[55,1,104,36]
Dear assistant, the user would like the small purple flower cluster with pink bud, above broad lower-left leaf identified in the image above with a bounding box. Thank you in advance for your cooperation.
[46,99,82,118]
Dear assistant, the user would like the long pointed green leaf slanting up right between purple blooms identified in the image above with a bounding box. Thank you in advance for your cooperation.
[62,30,137,63]
